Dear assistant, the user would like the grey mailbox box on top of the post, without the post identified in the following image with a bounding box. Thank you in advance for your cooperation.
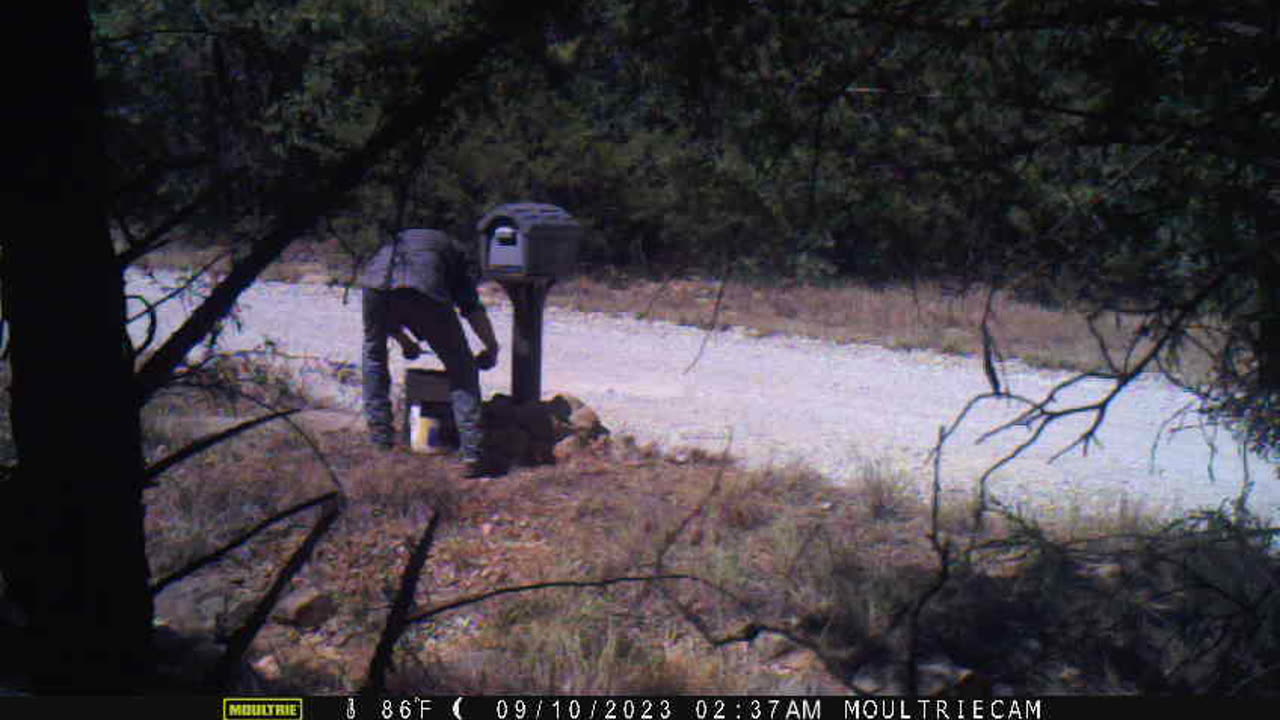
[476,202,582,279]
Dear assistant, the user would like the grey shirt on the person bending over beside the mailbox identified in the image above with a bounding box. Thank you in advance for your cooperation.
[356,228,480,314]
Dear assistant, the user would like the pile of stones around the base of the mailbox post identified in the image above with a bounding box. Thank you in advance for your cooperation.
[484,393,609,465]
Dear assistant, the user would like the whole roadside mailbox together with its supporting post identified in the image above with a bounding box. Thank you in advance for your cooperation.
[476,202,582,405]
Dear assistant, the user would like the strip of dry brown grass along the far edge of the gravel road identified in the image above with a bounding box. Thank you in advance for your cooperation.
[124,242,1182,370]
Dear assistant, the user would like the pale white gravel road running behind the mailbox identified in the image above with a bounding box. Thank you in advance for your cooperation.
[129,273,1280,518]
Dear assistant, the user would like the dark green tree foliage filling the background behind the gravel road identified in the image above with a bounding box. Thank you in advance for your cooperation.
[85,0,1280,461]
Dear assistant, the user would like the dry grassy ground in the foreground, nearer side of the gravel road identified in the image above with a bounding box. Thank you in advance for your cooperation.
[132,381,1280,694]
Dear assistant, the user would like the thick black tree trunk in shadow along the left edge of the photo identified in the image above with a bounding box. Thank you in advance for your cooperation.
[0,0,152,693]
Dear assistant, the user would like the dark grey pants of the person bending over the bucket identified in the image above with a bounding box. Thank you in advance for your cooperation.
[362,288,484,460]
